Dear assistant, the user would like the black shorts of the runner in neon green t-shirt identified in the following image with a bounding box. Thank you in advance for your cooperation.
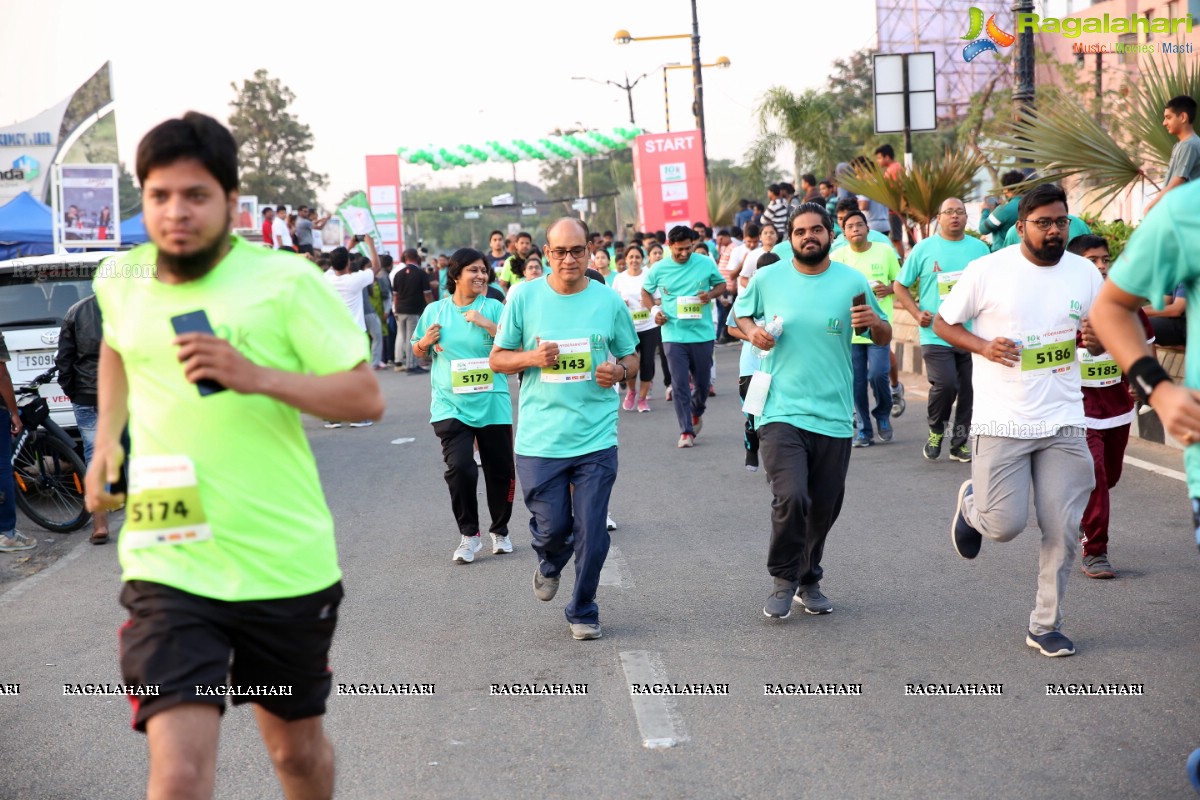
[119,581,343,732]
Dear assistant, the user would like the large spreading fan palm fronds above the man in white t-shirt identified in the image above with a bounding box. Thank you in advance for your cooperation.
[989,58,1200,214]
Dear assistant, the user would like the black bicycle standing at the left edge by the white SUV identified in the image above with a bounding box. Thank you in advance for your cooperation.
[12,367,91,534]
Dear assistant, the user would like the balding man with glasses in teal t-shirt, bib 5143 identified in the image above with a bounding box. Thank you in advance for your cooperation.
[491,217,638,639]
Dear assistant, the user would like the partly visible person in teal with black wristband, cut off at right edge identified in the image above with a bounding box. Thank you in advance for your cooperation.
[1091,182,1200,506]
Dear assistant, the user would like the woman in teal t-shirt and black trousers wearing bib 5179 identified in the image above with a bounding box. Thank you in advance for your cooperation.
[413,248,516,564]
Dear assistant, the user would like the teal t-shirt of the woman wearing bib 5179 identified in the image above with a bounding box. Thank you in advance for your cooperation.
[412,295,512,428]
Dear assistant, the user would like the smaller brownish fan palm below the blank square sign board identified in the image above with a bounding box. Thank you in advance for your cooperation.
[839,150,983,239]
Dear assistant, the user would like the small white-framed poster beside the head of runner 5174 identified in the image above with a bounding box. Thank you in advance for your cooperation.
[54,164,121,247]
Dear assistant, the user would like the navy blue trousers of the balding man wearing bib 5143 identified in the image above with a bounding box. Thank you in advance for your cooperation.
[517,447,617,625]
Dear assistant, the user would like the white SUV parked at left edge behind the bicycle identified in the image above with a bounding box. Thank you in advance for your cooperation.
[0,251,113,428]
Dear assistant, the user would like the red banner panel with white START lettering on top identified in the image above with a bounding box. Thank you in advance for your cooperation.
[634,131,708,230]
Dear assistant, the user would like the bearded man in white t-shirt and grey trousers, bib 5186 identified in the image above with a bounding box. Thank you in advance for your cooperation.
[934,184,1104,656]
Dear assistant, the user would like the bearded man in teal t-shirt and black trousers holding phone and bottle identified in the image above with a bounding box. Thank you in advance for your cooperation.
[733,204,892,619]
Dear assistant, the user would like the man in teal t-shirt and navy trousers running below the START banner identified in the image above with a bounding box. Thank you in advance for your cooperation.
[642,225,725,447]
